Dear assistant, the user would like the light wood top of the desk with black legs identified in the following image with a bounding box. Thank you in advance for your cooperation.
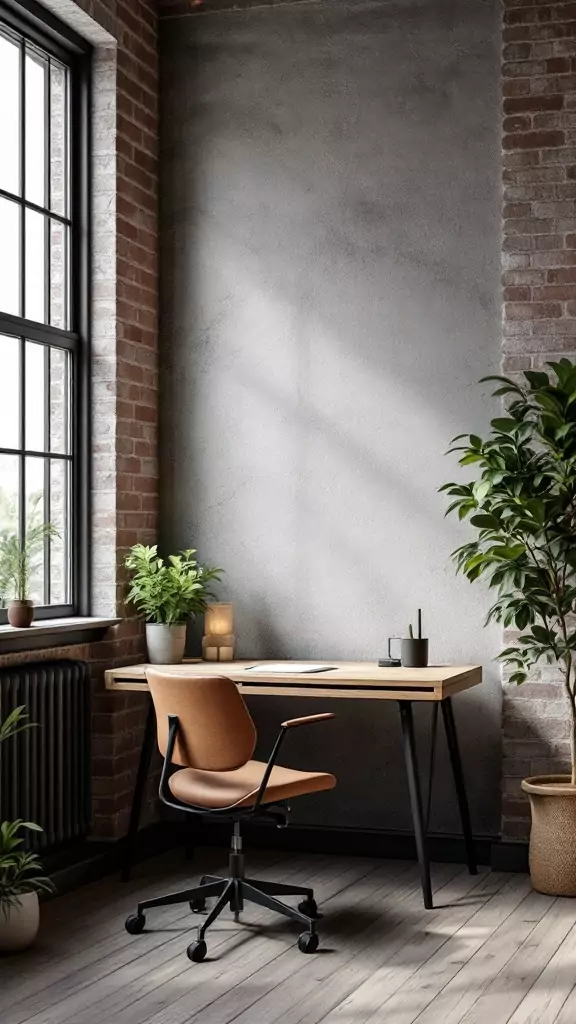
[105,658,482,700]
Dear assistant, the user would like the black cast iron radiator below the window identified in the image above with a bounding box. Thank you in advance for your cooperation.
[0,660,91,850]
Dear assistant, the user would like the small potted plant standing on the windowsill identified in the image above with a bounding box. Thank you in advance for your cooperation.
[0,522,58,629]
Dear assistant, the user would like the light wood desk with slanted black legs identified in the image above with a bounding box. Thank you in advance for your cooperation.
[105,659,482,908]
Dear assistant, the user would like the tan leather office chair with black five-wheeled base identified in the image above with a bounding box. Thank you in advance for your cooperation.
[126,669,336,962]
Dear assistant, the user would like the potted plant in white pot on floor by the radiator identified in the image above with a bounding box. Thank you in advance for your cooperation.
[0,707,53,952]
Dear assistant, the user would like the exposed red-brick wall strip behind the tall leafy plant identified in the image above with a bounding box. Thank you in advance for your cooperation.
[502,0,576,839]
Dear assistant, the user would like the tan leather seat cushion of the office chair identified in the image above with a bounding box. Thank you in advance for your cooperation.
[168,761,336,808]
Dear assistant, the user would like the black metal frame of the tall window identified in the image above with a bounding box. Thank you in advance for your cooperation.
[0,0,92,626]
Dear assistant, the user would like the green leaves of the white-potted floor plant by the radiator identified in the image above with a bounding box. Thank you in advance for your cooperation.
[0,706,54,919]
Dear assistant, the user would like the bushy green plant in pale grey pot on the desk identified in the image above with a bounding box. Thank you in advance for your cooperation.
[125,544,222,665]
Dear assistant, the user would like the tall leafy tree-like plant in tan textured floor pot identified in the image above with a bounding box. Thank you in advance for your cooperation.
[441,358,576,896]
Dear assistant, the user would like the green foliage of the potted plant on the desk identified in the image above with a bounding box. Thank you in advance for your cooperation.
[125,544,222,626]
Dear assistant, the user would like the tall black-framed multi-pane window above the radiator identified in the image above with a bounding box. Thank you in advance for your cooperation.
[0,3,88,622]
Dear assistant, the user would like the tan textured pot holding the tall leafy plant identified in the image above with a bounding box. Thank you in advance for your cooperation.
[522,775,576,896]
